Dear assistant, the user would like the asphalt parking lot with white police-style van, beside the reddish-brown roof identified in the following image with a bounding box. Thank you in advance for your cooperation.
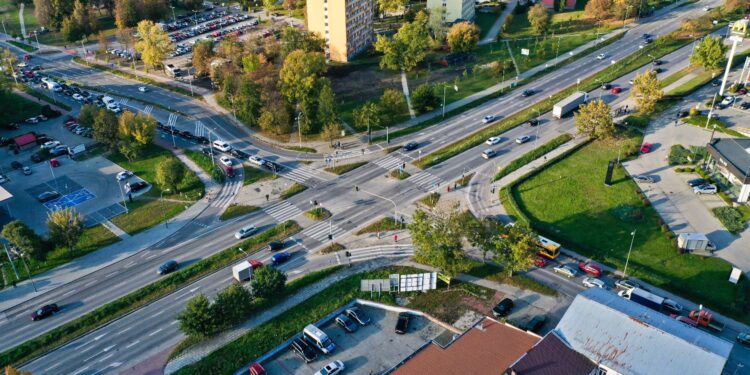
[262,307,445,374]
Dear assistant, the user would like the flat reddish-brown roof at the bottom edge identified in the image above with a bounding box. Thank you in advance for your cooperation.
[392,318,540,375]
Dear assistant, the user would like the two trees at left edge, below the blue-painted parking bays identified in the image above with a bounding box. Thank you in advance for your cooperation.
[1,208,84,261]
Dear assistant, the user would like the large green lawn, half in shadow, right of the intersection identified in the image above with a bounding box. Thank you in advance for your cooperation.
[506,136,748,321]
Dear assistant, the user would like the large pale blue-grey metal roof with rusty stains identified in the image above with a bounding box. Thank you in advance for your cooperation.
[555,288,733,375]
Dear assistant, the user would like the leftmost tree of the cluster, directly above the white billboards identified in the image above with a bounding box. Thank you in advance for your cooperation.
[408,210,466,276]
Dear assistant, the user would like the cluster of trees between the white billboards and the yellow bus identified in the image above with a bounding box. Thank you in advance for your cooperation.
[408,210,538,276]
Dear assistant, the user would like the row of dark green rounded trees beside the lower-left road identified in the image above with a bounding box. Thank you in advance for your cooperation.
[177,267,286,337]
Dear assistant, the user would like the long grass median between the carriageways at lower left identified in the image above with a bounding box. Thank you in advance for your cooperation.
[0,221,301,367]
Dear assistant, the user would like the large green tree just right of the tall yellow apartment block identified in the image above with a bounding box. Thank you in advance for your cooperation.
[375,11,430,71]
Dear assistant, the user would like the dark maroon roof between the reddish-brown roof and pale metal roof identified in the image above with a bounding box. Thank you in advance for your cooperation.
[509,331,597,375]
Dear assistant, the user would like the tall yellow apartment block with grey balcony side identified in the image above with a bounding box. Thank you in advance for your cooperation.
[305,0,375,62]
